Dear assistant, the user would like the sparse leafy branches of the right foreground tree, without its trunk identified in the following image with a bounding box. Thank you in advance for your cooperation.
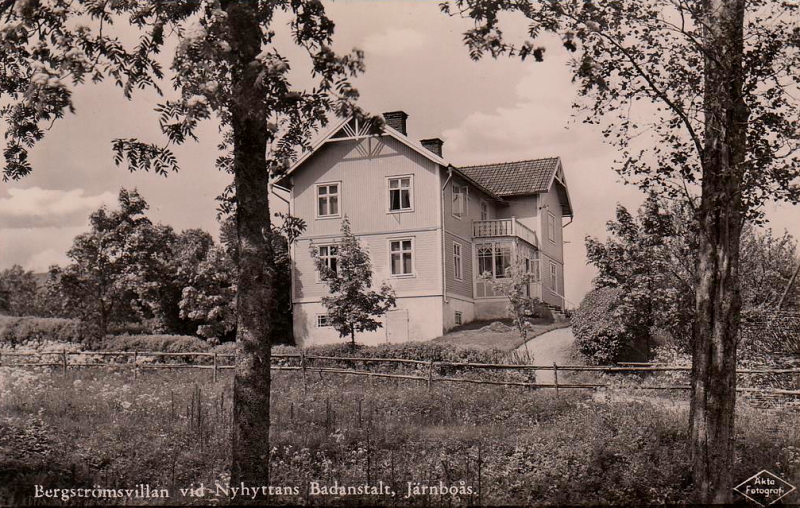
[441,0,800,213]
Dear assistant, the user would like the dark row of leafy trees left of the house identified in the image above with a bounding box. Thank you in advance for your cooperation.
[0,189,303,348]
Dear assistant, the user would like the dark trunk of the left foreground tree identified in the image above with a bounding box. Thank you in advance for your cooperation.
[222,0,275,492]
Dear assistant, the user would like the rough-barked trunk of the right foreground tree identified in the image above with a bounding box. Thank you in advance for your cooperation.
[690,0,748,504]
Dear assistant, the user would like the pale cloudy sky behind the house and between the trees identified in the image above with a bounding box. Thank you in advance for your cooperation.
[0,0,800,304]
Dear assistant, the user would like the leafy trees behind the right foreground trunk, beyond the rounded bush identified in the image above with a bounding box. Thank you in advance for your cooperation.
[575,195,797,358]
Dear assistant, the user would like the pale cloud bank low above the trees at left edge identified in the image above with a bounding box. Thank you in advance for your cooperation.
[0,187,116,228]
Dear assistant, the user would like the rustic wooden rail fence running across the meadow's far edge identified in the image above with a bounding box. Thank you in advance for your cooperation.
[0,351,800,396]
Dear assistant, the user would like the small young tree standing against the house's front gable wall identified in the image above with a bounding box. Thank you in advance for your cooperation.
[310,217,396,348]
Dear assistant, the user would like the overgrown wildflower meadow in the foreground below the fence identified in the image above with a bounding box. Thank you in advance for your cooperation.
[0,367,800,506]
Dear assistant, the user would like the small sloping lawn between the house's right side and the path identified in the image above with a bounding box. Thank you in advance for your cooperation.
[432,319,569,351]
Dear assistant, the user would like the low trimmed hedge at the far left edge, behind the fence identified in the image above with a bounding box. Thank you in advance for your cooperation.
[0,316,86,348]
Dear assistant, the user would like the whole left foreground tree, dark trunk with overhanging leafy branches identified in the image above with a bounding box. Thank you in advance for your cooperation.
[0,0,363,485]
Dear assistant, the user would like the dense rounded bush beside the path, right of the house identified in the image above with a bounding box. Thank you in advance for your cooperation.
[570,288,633,364]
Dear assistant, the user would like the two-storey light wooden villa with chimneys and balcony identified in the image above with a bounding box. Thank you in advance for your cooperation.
[274,111,572,345]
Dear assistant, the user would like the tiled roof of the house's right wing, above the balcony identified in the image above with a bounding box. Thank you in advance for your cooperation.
[458,157,560,196]
